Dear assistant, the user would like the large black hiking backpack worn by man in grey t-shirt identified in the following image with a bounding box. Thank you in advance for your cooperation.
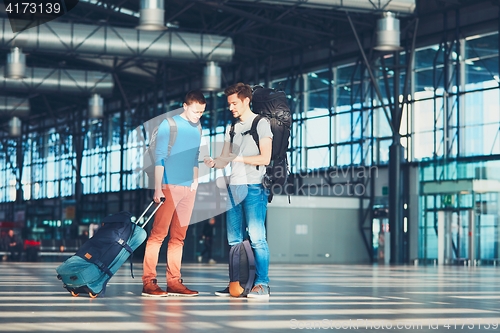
[233,86,292,202]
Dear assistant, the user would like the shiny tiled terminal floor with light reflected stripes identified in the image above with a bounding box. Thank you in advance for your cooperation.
[0,262,500,333]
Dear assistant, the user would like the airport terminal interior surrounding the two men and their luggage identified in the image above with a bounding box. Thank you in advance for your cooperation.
[0,0,500,332]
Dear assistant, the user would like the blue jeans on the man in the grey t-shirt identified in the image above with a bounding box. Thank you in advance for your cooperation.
[227,184,269,286]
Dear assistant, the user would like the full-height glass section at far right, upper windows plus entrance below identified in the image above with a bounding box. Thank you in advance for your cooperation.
[413,33,500,262]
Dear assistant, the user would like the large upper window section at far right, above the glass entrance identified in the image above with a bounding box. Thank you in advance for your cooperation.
[412,33,500,160]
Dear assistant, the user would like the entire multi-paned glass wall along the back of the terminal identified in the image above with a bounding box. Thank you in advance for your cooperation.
[0,28,500,258]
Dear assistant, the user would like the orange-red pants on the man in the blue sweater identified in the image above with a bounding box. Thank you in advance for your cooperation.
[142,185,196,284]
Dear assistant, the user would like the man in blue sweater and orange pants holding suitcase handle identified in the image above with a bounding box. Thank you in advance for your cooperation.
[142,91,207,297]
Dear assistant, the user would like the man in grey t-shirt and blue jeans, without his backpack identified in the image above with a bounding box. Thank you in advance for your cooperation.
[204,83,273,298]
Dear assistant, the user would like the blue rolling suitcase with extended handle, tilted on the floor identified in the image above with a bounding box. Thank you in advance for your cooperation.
[56,198,165,298]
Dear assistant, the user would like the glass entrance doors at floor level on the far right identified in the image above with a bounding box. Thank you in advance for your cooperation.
[419,193,500,265]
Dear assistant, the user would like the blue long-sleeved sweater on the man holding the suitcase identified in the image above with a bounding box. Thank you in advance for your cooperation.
[155,115,201,186]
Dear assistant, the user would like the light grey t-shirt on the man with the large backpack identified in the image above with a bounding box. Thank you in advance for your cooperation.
[224,114,273,185]
